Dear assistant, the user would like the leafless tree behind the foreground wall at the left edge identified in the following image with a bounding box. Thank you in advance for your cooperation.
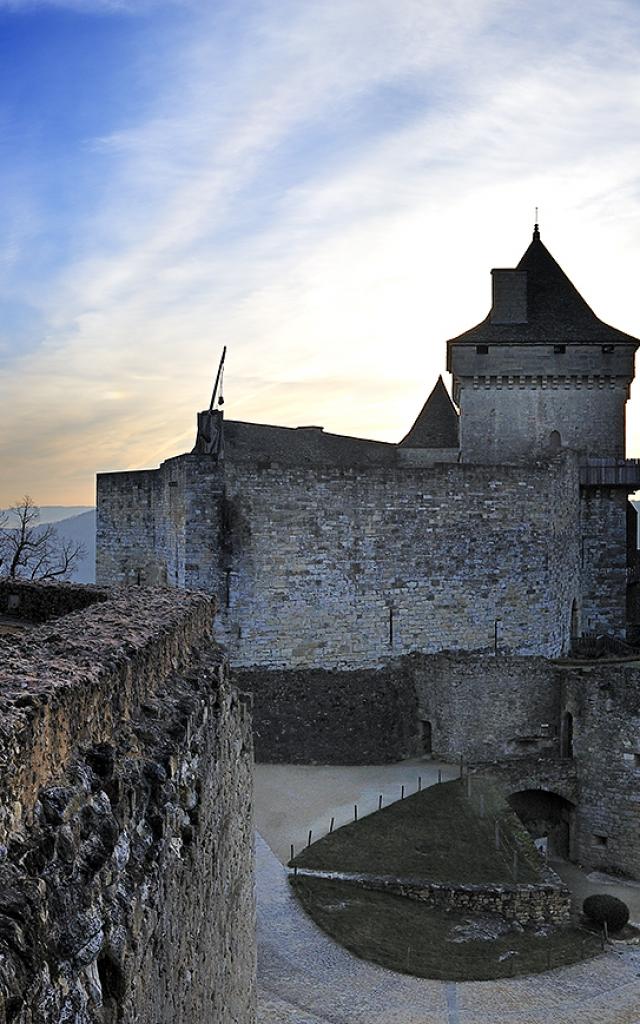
[0,495,85,580]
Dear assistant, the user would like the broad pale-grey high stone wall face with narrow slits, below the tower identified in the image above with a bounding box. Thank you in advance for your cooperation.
[218,457,579,669]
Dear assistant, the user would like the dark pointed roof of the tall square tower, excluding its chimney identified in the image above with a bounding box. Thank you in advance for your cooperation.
[451,225,638,345]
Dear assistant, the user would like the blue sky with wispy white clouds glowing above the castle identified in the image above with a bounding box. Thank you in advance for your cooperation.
[0,0,640,506]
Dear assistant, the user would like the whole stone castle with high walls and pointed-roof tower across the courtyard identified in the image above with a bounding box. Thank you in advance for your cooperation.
[97,226,640,874]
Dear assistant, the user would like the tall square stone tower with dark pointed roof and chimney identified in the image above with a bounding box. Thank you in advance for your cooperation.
[446,224,639,463]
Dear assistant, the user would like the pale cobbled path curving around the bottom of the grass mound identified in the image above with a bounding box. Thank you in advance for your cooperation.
[256,836,640,1024]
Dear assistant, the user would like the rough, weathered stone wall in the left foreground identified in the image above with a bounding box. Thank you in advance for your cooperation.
[0,588,255,1024]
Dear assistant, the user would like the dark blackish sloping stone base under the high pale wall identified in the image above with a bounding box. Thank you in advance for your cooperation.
[231,664,421,765]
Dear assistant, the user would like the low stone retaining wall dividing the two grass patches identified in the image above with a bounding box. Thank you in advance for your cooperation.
[298,868,571,925]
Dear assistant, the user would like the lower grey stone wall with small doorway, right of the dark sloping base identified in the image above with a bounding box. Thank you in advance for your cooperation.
[407,653,560,761]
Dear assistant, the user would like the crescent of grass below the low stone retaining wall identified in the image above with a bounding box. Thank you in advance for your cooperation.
[291,876,600,981]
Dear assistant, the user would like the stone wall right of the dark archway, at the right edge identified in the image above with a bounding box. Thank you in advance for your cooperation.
[562,663,640,878]
